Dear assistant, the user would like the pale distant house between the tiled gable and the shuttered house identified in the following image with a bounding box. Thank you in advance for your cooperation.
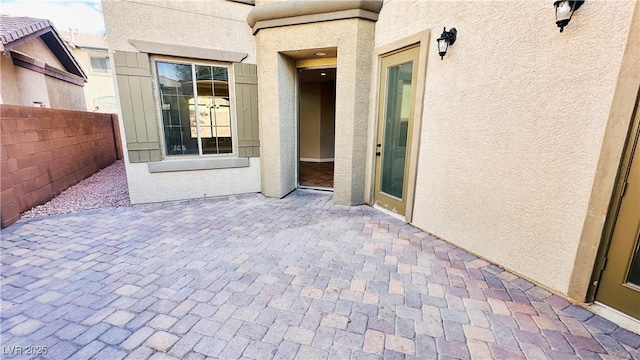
[59,30,117,113]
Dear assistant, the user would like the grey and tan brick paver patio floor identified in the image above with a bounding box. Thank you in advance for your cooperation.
[0,191,640,360]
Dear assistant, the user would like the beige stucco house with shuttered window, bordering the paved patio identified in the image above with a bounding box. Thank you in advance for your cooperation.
[103,0,640,324]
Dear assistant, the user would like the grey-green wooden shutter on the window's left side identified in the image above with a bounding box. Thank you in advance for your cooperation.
[113,51,162,163]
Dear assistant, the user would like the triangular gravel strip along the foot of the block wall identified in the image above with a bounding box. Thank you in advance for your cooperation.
[22,160,131,219]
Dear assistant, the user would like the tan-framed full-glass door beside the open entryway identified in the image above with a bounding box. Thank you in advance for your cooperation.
[374,46,420,215]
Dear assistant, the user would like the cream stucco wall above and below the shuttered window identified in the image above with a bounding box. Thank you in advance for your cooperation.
[103,0,260,204]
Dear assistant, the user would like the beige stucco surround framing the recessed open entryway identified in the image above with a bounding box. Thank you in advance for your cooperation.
[256,19,374,205]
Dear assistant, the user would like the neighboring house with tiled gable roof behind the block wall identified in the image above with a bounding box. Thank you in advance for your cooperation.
[0,15,87,110]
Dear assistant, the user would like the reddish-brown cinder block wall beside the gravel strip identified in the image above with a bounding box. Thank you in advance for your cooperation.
[0,105,122,228]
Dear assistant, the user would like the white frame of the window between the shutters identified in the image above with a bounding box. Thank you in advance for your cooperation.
[151,55,238,160]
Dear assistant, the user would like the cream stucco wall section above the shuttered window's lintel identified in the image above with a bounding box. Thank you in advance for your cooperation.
[102,0,255,64]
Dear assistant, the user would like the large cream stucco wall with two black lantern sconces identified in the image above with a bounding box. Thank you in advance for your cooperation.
[371,1,634,294]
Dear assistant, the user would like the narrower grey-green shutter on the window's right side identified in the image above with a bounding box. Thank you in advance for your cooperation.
[233,63,260,157]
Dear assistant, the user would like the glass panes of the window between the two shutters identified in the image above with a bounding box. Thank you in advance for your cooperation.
[156,61,233,155]
